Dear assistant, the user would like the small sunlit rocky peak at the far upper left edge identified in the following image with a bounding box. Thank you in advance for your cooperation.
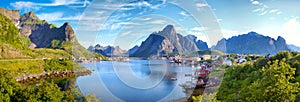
[0,8,20,27]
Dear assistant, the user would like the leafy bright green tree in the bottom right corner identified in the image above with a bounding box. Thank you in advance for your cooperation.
[242,58,299,102]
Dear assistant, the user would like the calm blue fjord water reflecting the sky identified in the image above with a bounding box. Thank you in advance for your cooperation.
[76,60,192,102]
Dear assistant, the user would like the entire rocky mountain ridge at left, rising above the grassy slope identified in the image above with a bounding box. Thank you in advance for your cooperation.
[0,8,101,58]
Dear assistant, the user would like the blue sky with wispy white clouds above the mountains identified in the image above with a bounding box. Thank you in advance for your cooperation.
[0,0,300,49]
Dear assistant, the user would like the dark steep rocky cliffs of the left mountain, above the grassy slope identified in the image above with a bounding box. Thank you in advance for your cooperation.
[20,12,77,48]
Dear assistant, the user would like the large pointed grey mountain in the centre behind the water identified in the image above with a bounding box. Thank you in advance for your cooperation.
[129,25,199,57]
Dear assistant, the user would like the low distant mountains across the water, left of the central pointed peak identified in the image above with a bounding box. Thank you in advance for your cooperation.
[88,44,126,57]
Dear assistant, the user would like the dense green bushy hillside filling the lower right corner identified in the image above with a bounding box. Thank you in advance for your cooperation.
[216,51,300,102]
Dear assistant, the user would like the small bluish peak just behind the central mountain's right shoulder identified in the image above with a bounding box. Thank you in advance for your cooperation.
[185,35,209,50]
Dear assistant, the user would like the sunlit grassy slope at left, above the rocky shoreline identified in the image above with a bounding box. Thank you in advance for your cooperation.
[0,14,85,76]
